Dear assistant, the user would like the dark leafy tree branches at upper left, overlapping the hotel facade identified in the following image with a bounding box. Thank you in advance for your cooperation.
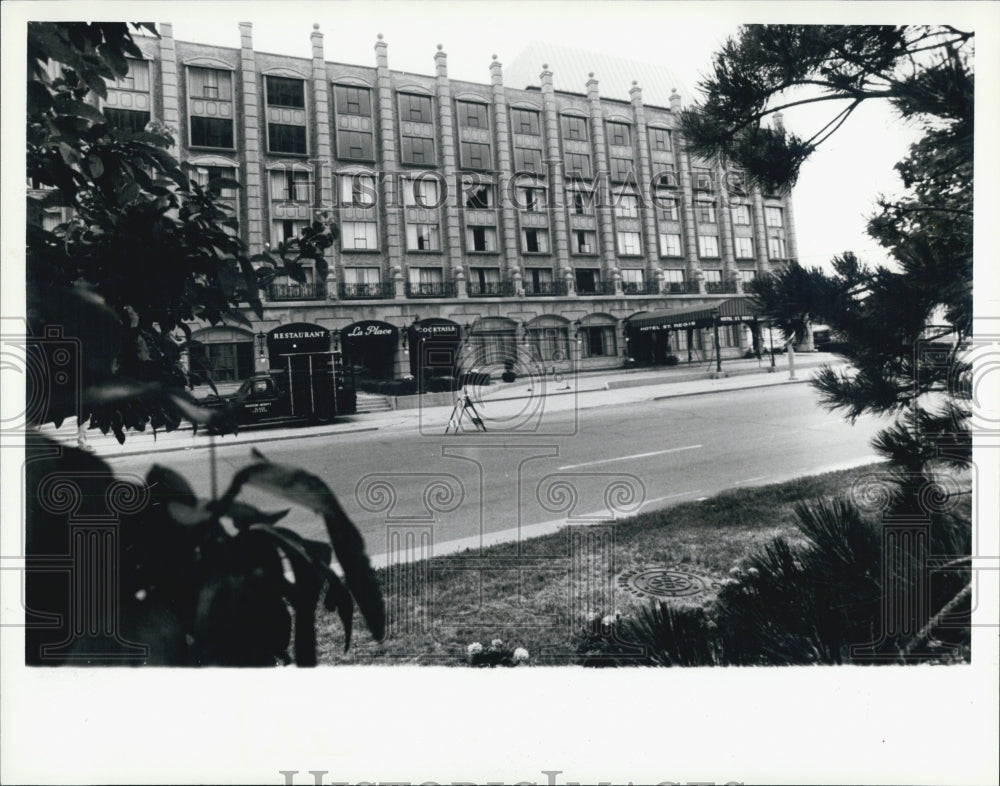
[25,22,335,440]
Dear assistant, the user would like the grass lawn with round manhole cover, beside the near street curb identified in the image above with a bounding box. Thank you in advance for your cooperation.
[317,464,881,665]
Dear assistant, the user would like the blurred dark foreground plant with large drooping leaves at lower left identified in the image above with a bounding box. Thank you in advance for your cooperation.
[26,440,385,666]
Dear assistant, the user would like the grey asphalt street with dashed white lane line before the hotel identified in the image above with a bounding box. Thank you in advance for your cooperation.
[108,385,882,562]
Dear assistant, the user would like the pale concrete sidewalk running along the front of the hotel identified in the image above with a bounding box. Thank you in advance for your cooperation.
[42,353,842,459]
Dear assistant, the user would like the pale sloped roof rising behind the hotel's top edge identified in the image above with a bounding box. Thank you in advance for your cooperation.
[503,41,693,109]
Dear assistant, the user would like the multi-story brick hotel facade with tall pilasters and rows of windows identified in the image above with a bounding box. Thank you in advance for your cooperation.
[39,23,795,390]
